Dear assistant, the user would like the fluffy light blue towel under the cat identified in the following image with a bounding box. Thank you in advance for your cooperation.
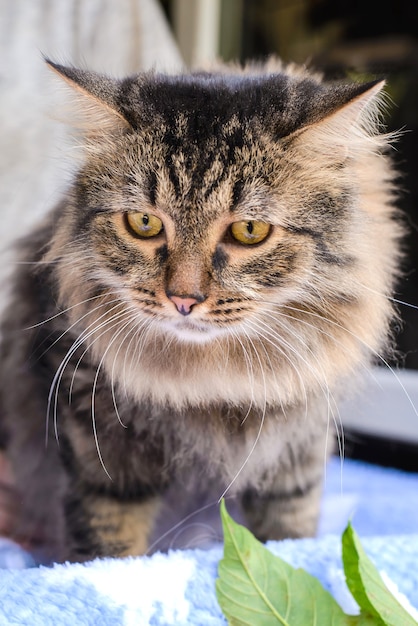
[0,459,418,626]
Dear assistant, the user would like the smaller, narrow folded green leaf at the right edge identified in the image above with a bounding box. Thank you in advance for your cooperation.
[342,523,418,626]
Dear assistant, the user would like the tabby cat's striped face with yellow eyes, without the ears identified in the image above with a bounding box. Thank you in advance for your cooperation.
[85,117,314,341]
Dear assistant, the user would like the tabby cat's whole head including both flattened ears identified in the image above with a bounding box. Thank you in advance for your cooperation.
[45,64,393,358]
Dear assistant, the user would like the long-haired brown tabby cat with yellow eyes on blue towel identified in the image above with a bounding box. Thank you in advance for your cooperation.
[0,60,402,561]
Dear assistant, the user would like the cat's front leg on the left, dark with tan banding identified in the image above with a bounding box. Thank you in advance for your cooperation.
[60,408,169,561]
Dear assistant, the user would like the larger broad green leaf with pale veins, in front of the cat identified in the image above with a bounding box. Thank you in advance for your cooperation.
[216,501,362,626]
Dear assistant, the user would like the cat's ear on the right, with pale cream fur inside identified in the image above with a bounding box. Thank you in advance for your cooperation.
[295,80,385,158]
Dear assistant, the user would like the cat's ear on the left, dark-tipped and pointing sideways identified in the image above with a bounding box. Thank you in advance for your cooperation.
[45,58,130,135]
